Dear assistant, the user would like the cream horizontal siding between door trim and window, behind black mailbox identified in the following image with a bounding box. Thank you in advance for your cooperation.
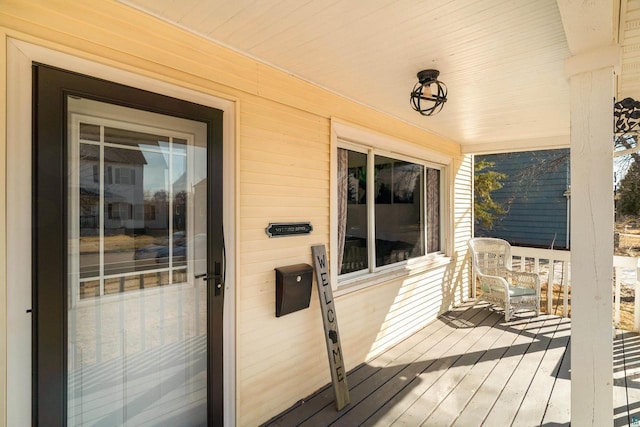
[237,98,330,424]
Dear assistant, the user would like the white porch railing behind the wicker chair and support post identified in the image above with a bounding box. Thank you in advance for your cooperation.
[474,246,640,331]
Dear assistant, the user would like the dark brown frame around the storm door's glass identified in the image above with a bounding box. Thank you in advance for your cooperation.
[32,64,224,426]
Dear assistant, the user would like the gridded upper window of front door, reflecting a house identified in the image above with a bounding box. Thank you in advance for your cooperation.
[79,123,187,299]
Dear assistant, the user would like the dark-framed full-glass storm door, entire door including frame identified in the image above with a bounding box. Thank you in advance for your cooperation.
[34,66,223,426]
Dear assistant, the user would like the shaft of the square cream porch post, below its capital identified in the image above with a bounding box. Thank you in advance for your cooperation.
[570,66,614,426]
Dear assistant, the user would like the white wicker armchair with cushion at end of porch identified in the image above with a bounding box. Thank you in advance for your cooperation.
[469,237,540,322]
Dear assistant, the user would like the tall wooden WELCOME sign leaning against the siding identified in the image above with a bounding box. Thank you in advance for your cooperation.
[311,245,349,411]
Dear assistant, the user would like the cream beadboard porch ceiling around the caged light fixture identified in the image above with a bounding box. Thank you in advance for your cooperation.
[121,0,640,152]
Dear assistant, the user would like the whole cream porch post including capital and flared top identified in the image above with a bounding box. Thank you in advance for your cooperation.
[557,0,620,426]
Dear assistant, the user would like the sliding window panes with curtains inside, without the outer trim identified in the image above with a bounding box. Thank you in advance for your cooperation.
[336,144,444,280]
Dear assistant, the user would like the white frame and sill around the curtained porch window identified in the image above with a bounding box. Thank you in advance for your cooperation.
[330,119,453,296]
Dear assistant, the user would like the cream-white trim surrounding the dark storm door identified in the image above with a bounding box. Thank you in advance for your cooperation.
[5,38,237,426]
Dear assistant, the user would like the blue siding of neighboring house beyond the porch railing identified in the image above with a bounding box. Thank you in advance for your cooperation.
[475,149,569,249]
